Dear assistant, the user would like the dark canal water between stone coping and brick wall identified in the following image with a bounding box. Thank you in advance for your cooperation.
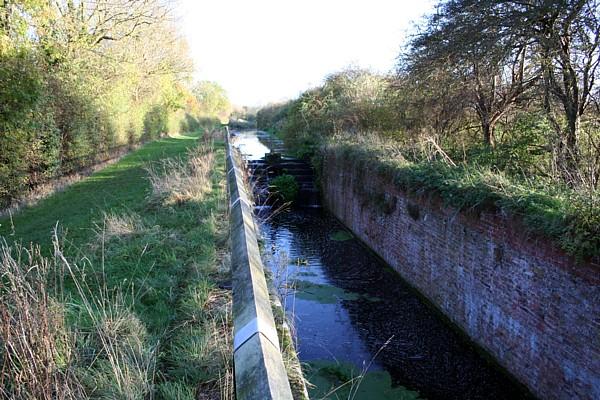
[236,131,530,400]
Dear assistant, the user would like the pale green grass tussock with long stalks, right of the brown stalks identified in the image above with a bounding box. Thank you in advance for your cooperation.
[54,234,158,400]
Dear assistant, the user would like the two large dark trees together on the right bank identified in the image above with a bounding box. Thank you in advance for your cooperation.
[413,0,600,183]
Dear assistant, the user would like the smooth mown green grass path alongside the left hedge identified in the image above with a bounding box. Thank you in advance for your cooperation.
[0,135,202,248]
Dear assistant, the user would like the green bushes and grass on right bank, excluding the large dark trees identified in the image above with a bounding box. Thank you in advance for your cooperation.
[257,51,600,260]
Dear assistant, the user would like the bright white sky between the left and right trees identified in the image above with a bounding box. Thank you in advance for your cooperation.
[179,0,435,106]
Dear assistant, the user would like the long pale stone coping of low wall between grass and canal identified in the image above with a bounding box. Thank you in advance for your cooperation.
[226,138,293,400]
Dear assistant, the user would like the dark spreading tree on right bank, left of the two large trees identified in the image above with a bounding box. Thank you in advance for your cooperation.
[399,0,539,146]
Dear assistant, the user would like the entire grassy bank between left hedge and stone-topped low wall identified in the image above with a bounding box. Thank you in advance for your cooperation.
[0,130,232,399]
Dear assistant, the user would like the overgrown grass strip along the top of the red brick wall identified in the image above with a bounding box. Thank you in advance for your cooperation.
[324,141,600,260]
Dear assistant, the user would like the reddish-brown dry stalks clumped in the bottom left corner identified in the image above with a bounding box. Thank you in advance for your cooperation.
[0,241,81,400]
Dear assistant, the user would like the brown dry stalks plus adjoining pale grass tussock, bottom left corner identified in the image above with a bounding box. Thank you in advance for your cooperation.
[0,234,156,400]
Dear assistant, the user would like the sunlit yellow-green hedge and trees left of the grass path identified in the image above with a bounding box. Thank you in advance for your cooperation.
[0,0,229,207]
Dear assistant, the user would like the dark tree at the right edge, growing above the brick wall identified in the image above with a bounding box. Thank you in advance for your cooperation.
[511,0,600,181]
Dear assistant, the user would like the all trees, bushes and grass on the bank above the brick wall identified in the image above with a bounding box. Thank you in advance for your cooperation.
[257,0,600,260]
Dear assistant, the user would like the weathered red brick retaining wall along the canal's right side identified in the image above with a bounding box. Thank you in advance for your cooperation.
[322,152,600,399]
